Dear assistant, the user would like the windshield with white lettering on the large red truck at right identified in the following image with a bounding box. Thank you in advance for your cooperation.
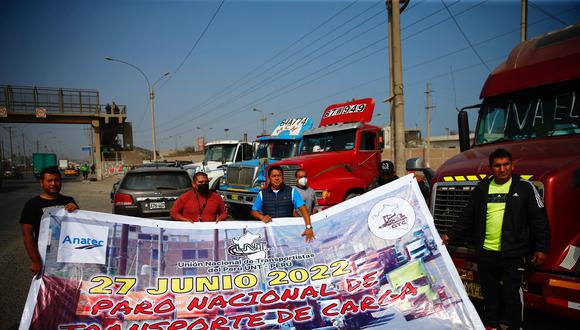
[475,80,580,145]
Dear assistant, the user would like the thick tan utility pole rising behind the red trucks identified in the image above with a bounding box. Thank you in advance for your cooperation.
[387,0,406,176]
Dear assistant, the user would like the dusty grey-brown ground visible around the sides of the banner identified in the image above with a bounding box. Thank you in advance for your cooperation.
[0,176,577,329]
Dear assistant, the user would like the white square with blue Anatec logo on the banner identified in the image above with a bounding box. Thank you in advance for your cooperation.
[57,222,109,265]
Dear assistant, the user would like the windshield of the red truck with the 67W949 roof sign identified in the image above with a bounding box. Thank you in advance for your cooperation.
[301,129,356,154]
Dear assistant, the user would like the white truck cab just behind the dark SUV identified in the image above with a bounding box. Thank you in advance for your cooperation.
[183,140,254,190]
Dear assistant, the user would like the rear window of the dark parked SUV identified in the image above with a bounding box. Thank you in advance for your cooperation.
[121,172,191,190]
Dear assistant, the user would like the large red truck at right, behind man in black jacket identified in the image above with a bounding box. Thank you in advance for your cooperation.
[431,25,580,318]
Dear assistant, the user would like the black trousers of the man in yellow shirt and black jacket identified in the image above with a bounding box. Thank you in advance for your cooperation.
[477,250,525,329]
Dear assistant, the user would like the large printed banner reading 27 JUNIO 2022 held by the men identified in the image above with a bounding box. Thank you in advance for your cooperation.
[20,175,483,330]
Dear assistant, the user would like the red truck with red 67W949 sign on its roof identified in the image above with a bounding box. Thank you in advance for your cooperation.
[274,98,384,208]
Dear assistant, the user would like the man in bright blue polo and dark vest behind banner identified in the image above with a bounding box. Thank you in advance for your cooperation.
[252,165,314,242]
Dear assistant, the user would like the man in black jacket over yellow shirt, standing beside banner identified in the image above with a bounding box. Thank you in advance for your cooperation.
[442,148,550,329]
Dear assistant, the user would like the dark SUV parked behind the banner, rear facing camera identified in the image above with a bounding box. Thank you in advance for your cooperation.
[111,167,191,219]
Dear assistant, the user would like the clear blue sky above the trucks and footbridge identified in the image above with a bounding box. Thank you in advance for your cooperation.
[0,0,580,160]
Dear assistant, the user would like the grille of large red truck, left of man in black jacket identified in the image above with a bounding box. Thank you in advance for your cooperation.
[433,182,477,235]
